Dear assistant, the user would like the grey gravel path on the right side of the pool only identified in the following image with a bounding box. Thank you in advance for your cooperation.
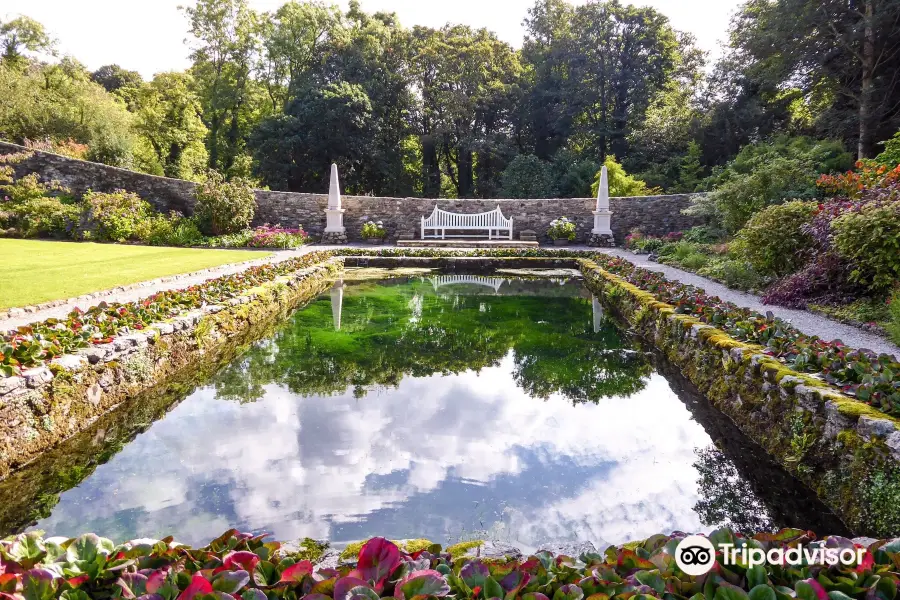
[604,248,900,356]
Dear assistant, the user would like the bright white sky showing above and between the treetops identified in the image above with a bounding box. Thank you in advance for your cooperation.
[0,0,740,79]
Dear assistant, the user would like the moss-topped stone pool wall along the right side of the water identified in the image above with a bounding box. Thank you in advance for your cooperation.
[579,259,900,537]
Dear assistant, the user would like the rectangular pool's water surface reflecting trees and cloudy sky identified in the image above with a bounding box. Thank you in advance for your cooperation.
[0,275,848,548]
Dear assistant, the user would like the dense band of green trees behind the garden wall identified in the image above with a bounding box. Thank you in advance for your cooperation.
[0,0,900,193]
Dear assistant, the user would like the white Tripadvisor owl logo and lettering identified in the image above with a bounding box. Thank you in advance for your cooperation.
[675,535,866,577]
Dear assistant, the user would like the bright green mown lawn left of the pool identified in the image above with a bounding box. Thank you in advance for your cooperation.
[0,239,271,308]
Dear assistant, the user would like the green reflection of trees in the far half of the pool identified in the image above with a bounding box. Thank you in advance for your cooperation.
[214,279,651,402]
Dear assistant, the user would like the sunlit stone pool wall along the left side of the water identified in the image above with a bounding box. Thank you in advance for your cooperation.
[0,257,343,479]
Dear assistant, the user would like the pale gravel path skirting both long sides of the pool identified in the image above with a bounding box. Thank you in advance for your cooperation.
[0,244,900,356]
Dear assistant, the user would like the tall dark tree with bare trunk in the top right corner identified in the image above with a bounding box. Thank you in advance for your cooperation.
[731,0,900,158]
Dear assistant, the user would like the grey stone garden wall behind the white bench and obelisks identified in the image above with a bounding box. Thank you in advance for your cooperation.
[0,142,704,243]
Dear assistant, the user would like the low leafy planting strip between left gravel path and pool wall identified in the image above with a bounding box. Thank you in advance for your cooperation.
[0,252,331,376]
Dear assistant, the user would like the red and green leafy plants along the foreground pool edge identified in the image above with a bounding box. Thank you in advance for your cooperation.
[0,529,900,600]
